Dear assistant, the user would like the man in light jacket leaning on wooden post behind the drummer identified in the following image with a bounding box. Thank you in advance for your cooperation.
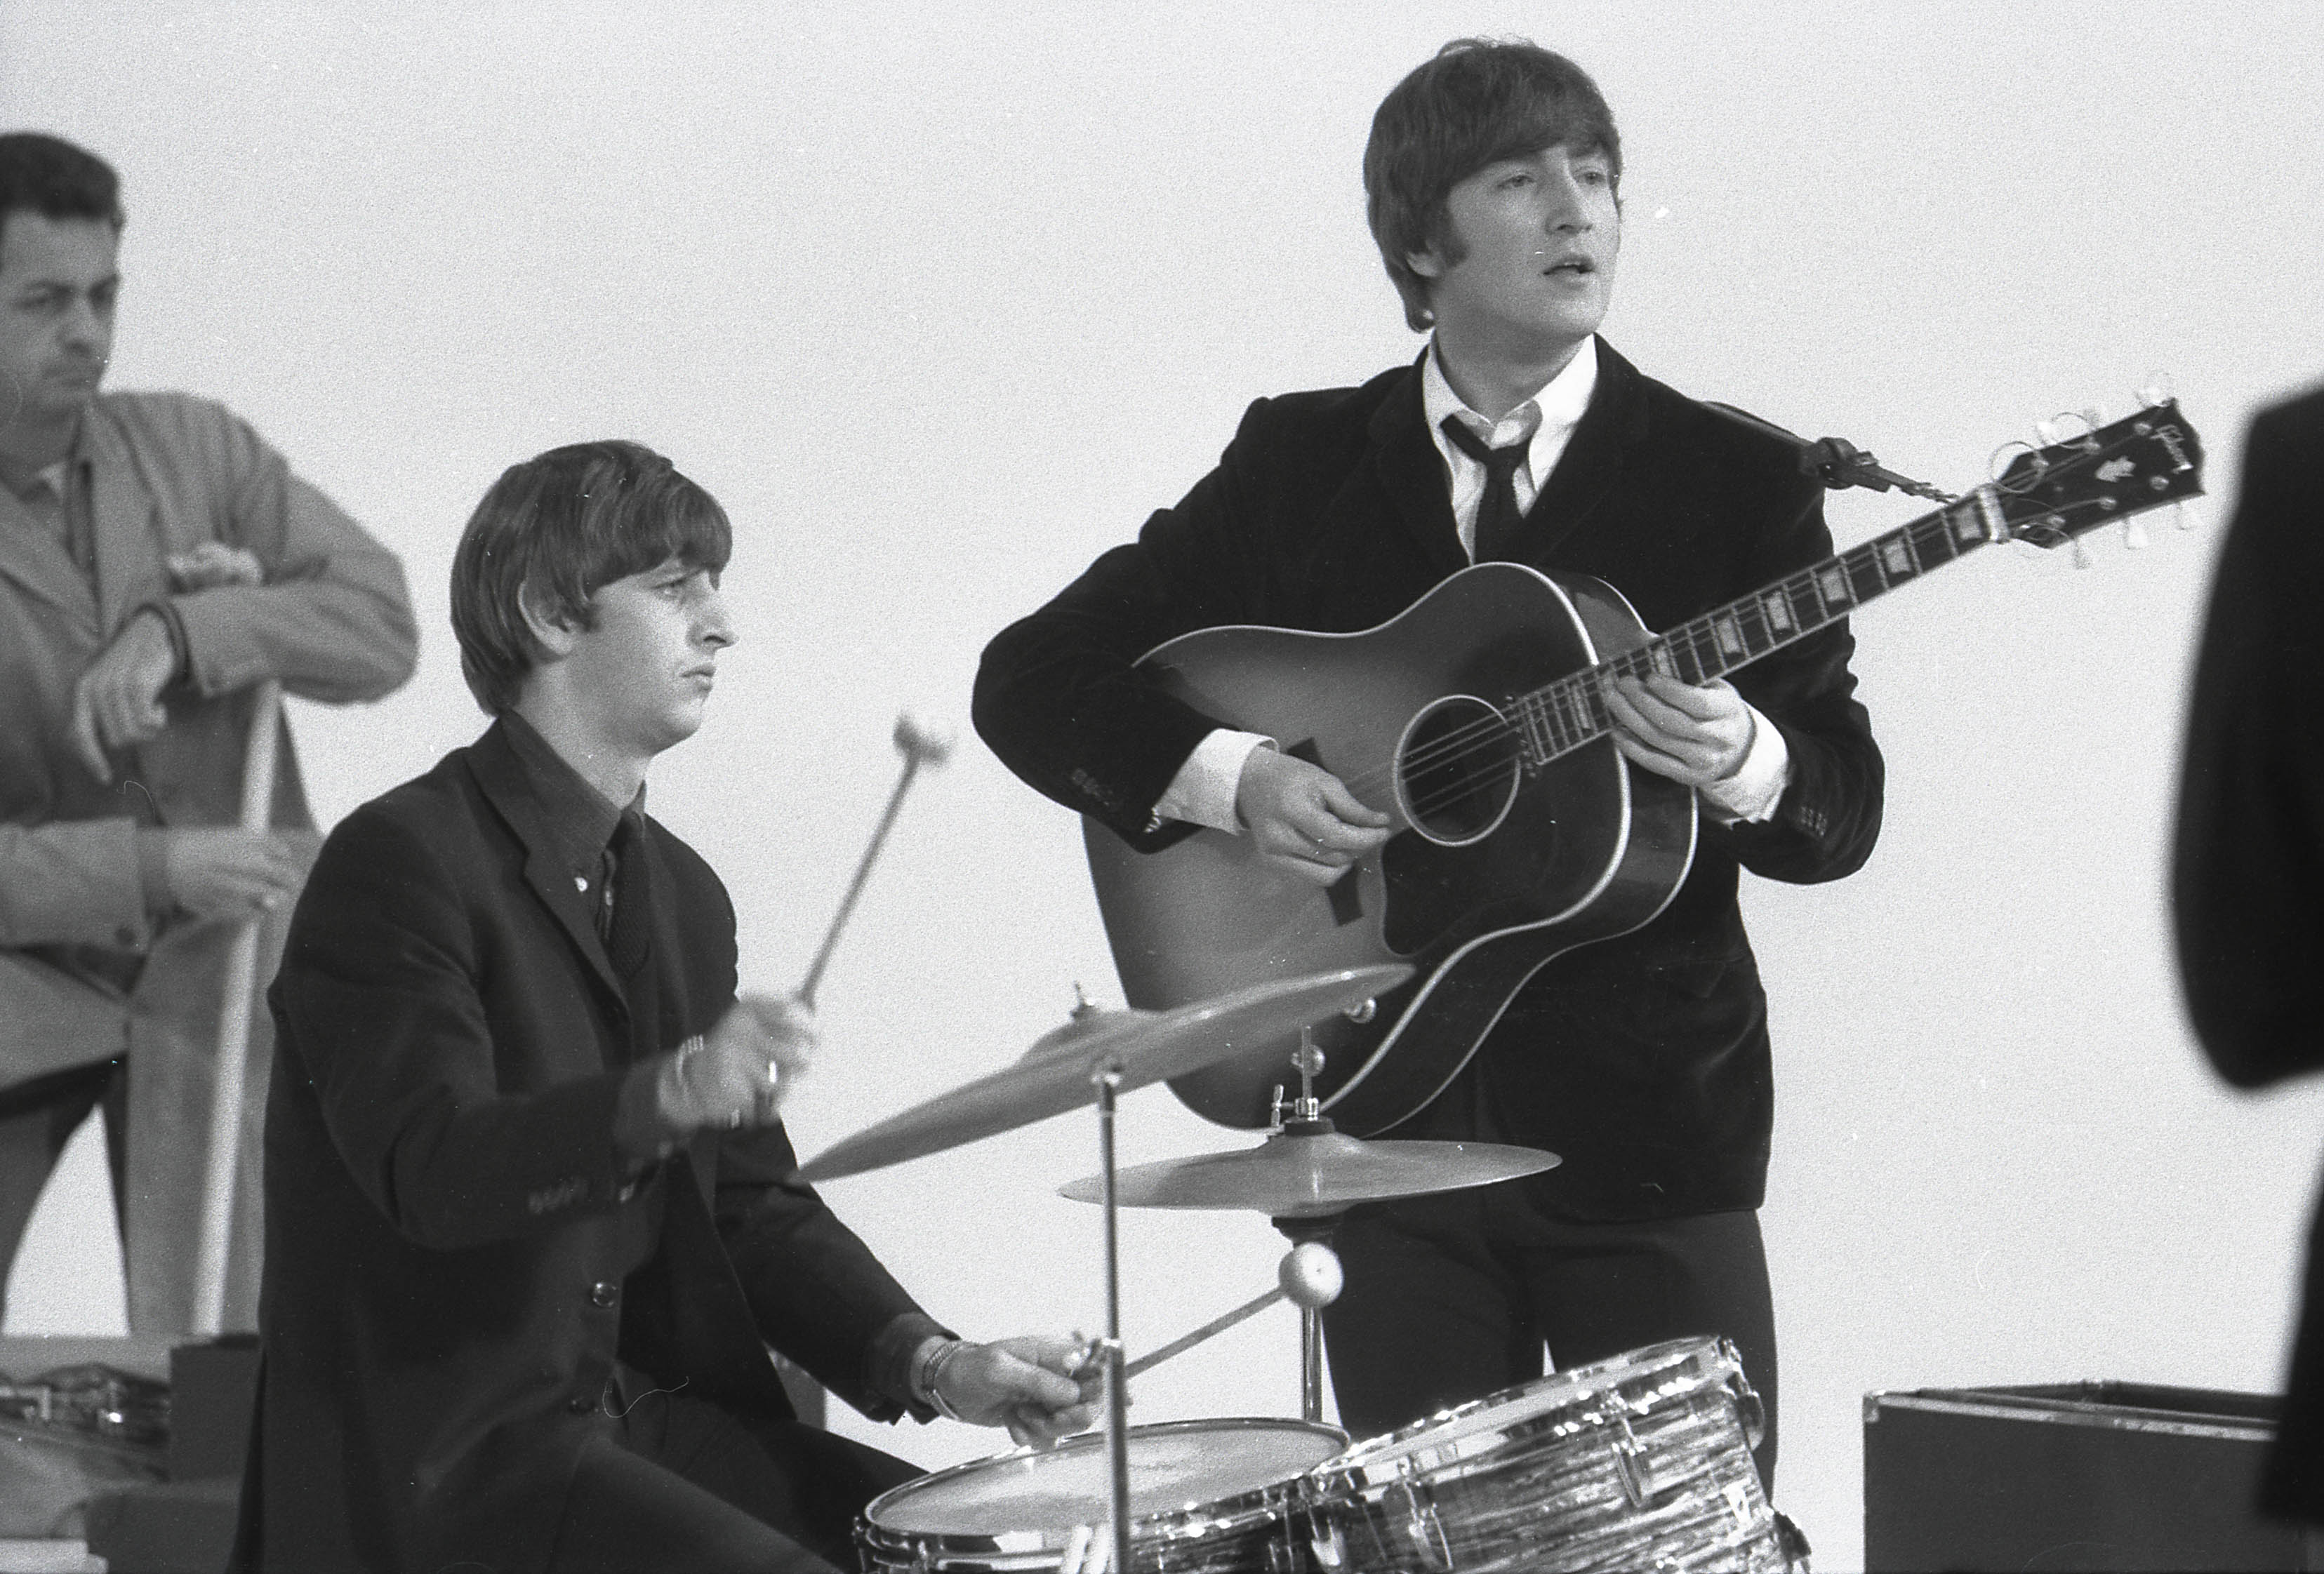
[0,133,416,1335]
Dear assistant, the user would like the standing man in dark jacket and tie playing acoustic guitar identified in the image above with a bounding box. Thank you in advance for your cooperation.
[976,39,1883,1481]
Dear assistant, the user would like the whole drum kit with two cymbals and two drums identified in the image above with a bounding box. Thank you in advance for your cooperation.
[799,967,1803,1574]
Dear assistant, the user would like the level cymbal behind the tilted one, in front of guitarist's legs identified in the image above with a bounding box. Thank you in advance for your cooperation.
[1058,1133,1560,1218]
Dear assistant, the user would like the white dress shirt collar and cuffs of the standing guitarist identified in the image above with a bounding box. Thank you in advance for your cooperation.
[1153,335,1792,834]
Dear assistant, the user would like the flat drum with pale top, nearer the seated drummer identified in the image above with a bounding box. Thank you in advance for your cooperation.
[855,1420,1348,1574]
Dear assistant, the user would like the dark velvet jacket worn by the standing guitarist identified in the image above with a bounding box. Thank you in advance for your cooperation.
[976,342,1883,1216]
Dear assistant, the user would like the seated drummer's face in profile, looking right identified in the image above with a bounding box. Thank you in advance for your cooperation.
[565,558,734,756]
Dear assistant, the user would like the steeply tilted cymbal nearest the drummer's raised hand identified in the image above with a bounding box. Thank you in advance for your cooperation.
[799,963,1413,1181]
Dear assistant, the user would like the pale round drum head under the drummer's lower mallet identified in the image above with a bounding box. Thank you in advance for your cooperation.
[865,1420,1348,1546]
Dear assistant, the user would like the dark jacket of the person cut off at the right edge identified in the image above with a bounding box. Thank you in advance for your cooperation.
[2173,376,2324,1523]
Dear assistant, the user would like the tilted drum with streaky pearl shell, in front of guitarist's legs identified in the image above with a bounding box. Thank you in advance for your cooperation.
[1306,1339,1792,1574]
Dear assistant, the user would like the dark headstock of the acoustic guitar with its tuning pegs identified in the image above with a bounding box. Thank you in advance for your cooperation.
[1994,400,2203,547]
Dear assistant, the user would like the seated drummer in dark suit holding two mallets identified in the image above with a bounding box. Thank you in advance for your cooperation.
[237,441,1090,1574]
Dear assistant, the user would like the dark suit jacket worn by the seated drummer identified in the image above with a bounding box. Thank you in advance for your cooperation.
[241,728,916,1574]
